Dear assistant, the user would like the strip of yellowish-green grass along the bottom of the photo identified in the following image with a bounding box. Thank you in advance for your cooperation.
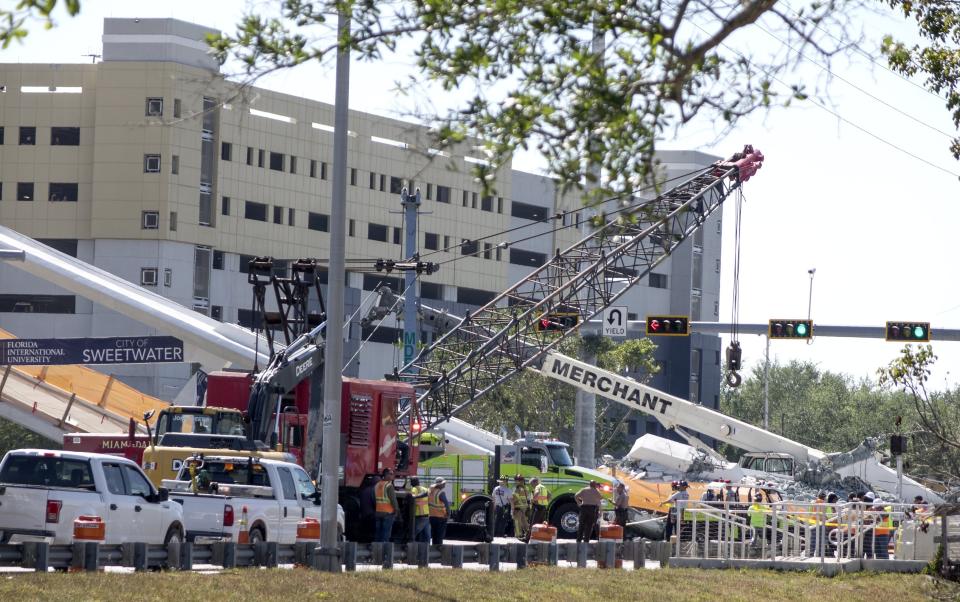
[0,568,960,602]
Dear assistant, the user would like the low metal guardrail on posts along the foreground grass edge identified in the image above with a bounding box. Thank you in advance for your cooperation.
[0,540,670,572]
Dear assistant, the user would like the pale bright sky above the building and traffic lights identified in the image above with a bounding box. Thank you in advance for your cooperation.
[7,0,960,388]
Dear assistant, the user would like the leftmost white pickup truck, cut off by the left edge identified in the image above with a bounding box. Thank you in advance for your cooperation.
[0,449,184,544]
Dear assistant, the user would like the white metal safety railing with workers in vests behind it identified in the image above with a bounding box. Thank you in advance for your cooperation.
[669,500,940,563]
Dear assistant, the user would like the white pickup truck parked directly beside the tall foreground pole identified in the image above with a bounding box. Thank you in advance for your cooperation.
[163,456,344,544]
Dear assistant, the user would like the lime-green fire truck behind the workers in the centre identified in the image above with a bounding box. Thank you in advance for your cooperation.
[417,433,613,538]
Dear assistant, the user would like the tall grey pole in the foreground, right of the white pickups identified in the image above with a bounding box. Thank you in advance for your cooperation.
[307,9,352,573]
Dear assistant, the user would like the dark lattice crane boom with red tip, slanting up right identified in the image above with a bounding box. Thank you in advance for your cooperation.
[396,146,763,430]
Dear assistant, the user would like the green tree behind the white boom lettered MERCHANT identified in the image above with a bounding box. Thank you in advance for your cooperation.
[460,337,659,455]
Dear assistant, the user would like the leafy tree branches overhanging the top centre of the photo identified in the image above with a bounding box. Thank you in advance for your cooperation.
[216,0,860,200]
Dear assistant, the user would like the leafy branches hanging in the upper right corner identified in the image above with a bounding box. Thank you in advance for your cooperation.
[881,0,960,159]
